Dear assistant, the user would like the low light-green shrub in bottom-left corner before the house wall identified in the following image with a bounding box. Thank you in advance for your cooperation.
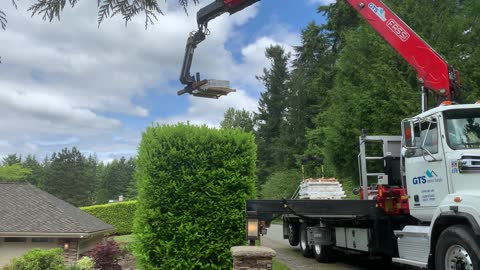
[3,248,65,270]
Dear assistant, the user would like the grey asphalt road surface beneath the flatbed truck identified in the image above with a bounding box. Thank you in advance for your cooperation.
[261,224,408,270]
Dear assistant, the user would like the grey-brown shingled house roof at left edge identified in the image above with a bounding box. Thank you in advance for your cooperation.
[0,183,114,238]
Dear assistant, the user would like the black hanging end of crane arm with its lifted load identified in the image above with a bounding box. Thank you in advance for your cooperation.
[177,0,259,99]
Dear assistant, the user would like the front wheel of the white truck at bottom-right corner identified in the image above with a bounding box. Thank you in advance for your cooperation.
[434,225,480,270]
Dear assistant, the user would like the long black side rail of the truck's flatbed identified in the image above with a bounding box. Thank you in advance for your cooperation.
[245,200,378,223]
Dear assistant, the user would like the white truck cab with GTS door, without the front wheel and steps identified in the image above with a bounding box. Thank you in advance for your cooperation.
[403,104,480,222]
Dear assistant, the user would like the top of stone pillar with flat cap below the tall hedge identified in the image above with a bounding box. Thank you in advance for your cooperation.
[230,246,277,270]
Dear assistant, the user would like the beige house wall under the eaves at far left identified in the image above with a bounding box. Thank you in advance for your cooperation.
[0,238,58,268]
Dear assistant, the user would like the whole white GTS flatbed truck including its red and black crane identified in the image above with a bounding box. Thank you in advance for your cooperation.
[178,0,480,270]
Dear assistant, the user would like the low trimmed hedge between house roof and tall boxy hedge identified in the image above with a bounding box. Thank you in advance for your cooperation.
[80,201,137,235]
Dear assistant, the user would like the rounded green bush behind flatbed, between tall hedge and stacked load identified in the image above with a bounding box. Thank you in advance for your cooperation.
[261,169,302,199]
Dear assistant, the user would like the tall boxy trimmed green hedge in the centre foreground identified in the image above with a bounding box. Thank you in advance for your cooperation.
[134,124,256,270]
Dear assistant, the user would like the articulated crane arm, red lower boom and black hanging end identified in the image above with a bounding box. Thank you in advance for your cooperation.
[179,0,460,108]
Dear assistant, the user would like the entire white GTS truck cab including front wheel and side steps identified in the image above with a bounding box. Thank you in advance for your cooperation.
[394,102,480,269]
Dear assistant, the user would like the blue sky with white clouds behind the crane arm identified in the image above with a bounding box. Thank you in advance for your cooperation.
[0,0,332,161]
